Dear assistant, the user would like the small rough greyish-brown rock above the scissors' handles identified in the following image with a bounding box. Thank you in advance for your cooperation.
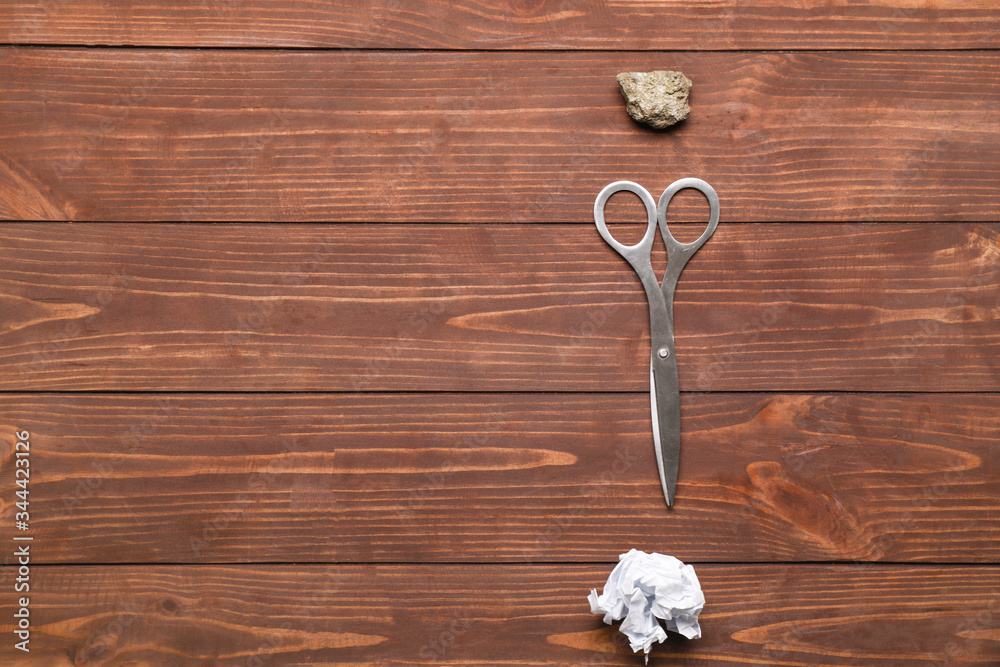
[618,70,691,130]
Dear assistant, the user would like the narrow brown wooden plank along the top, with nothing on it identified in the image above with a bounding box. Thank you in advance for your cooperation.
[0,0,1000,50]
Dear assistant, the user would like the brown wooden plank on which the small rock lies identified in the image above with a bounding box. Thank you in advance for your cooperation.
[0,48,1000,224]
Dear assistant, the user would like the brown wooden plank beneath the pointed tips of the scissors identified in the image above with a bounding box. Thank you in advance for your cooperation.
[0,394,1000,563]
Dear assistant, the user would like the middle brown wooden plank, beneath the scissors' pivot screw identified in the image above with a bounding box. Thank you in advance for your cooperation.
[0,223,1000,391]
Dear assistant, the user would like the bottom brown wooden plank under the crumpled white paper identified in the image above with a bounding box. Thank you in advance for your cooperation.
[0,556,1000,667]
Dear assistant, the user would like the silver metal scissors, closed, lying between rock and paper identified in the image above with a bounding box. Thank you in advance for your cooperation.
[594,178,719,507]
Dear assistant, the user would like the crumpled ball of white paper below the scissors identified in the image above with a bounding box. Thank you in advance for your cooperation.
[587,549,705,661]
